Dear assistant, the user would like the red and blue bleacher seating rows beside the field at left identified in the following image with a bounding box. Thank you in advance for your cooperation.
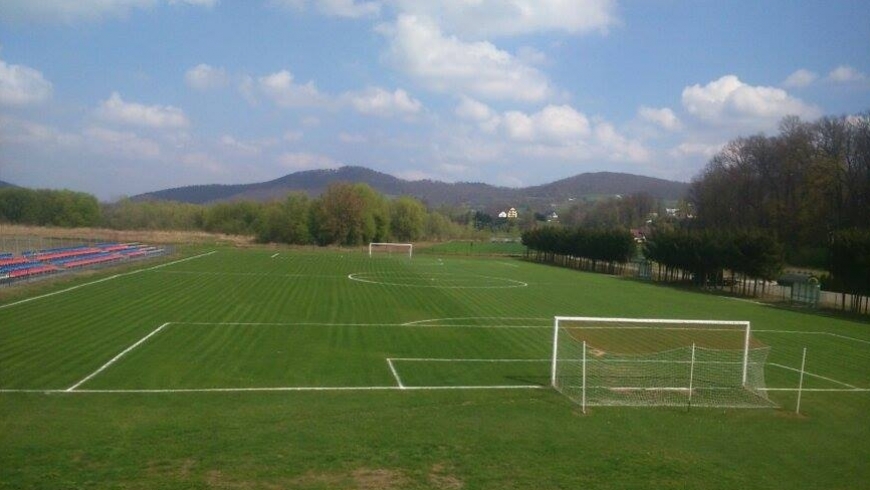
[0,243,165,282]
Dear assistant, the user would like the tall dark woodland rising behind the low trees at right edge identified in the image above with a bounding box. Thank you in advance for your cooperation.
[688,113,870,311]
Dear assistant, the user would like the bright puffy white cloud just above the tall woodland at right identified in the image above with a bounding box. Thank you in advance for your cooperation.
[682,75,820,130]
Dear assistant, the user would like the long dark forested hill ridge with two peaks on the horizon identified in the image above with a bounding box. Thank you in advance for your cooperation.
[133,167,688,207]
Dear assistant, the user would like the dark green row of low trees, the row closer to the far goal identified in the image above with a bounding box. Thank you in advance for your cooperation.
[522,226,635,273]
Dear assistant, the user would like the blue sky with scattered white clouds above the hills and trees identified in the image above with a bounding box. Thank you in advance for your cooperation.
[0,0,870,201]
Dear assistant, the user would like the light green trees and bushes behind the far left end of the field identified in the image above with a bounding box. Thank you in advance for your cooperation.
[0,183,473,246]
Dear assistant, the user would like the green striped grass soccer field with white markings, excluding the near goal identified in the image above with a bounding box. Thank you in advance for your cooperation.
[0,248,870,489]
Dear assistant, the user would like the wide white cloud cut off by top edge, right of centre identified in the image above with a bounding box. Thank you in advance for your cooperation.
[394,0,619,39]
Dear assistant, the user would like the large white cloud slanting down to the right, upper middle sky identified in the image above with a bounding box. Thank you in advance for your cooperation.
[379,15,552,102]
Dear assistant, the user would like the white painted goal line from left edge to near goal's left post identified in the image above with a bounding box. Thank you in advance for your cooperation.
[0,385,549,395]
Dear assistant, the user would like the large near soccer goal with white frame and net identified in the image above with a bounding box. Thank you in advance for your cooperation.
[550,317,775,413]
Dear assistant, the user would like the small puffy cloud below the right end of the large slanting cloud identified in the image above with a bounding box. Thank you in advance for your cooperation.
[504,105,590,144]
